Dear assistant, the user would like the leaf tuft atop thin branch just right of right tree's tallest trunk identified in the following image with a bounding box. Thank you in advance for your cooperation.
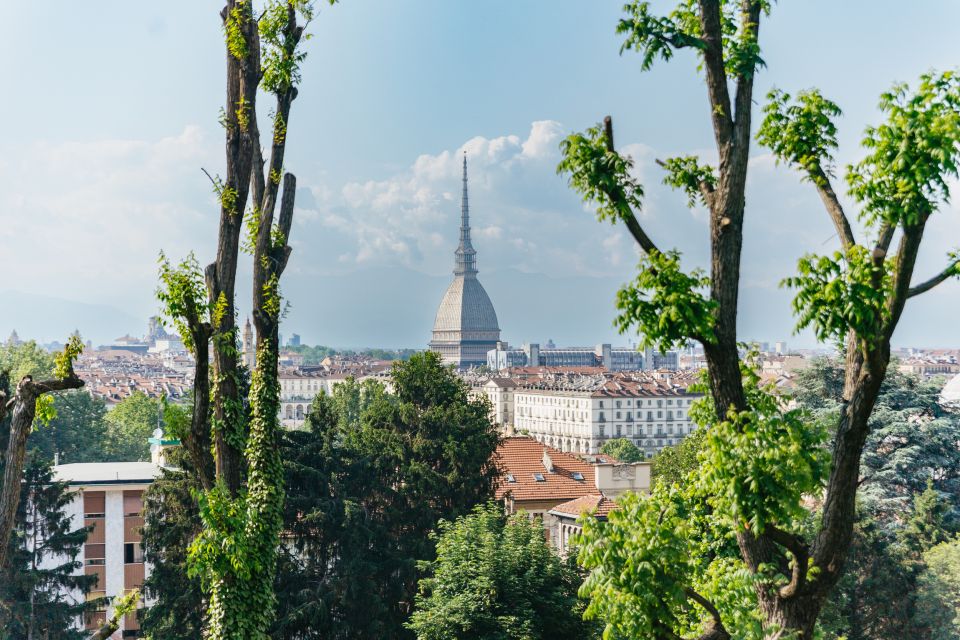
[757,89,841,186]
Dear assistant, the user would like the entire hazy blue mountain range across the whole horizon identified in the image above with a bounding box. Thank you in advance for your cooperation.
[0,267,960,348]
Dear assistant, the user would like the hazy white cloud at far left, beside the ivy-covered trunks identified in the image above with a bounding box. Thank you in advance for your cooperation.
[0,126,218,311]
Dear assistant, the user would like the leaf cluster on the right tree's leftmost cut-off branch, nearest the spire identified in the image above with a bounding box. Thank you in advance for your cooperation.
[557,124,643,223]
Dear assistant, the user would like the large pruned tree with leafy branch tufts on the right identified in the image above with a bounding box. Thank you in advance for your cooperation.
[558,0,960,640]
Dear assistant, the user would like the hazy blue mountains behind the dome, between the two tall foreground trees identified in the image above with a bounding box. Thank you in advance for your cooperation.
[281,268,627,347]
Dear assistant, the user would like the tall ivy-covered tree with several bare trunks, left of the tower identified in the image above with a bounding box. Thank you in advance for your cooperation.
[158,0,333,640]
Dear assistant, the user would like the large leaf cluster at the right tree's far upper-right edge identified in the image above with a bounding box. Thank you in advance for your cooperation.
[847,71,960,225]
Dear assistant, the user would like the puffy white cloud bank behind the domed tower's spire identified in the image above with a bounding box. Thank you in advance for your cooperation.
[294,120,646,276]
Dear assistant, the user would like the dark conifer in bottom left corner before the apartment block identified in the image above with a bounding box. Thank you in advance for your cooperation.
[0,457,96,640]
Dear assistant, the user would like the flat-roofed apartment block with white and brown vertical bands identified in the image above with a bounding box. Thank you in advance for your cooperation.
[50,462,160,640]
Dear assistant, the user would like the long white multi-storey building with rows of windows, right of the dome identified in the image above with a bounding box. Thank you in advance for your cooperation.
[513,374,699,458]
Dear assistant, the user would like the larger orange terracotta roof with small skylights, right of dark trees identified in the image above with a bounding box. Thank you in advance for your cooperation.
[496,436,597,502]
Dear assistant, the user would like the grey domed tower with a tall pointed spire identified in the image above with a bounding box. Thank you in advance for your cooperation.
[430,153,500,369]
